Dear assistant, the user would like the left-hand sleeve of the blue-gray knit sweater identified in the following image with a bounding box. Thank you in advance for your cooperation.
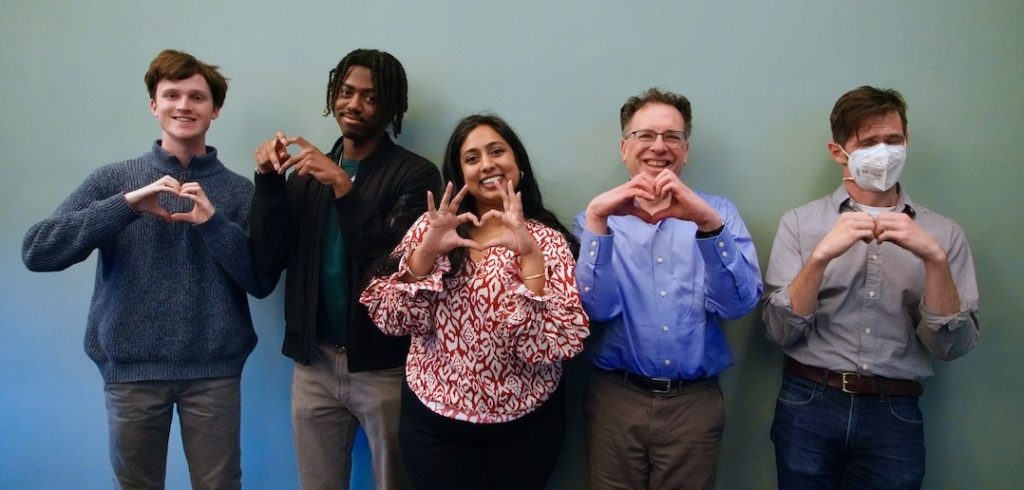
[22,168,139,272]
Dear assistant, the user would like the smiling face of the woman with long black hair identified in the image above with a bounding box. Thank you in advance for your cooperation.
[459,125,519,214]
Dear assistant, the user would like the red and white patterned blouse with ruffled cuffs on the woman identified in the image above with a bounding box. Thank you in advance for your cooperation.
[359,214,590,424]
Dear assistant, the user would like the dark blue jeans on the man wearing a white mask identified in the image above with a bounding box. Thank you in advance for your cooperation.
[771,374,925,490]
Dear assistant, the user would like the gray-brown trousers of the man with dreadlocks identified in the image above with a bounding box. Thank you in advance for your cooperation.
[292,344,412,490]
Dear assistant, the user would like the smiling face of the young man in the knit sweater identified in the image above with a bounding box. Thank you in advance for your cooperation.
[150,74,220,154]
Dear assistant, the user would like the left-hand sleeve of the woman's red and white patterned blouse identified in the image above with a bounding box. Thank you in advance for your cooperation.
[359,214,452,336]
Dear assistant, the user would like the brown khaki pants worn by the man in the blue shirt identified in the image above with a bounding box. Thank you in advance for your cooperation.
[584,371,725,490]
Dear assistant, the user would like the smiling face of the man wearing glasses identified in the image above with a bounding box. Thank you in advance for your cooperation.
[620,102,690,177]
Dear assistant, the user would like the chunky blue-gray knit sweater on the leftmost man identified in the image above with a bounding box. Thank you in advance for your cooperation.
[22,141,272,383]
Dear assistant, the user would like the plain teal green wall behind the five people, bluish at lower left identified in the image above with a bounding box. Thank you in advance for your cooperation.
[0,0,1024,489]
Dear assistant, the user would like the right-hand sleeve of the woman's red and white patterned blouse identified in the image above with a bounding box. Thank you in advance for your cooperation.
[505,225,590,363]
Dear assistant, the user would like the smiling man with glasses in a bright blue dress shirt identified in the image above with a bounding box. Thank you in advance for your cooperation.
[573,89,762,489]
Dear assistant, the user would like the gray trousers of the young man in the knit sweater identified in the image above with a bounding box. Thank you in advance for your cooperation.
[103,376,242,489]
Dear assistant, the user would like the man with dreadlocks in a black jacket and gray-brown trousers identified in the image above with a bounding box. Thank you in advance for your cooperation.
[251,49,440,489]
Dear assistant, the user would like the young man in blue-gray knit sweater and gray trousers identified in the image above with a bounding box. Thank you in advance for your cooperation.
[22,50,271,489]
